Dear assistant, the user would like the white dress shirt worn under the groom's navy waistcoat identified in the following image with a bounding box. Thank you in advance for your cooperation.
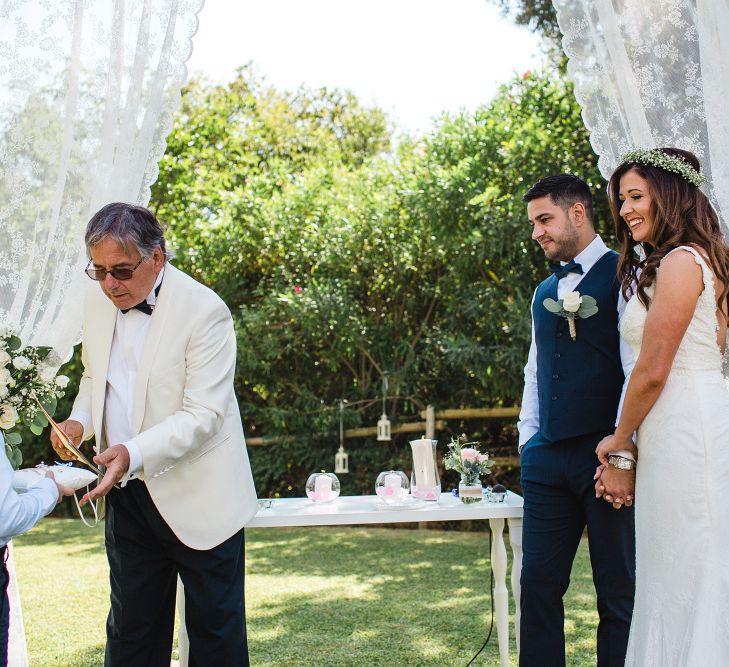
[517,236,635,448]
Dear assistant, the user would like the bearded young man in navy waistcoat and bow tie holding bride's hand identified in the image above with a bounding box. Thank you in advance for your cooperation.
[518,174,635,667]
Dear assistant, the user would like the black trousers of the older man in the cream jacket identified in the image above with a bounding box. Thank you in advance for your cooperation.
[104,480,249,667]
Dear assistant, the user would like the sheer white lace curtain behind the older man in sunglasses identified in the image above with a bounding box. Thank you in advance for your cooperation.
[0,0,203,357]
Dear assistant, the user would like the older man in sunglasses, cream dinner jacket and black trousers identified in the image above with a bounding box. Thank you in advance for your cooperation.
[54,204,257,667]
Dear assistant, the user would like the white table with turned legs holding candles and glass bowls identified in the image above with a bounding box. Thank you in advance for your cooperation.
[246,492,524,667]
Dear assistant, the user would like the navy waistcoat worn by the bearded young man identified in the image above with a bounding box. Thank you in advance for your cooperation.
[532,250,624,442]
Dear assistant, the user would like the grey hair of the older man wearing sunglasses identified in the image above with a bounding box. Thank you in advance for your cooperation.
[85,202,171,259]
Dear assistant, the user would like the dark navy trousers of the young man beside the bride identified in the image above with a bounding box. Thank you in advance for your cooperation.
[519,433,635,667]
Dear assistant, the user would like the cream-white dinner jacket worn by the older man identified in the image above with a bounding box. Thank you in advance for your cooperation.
[73,264,257,549]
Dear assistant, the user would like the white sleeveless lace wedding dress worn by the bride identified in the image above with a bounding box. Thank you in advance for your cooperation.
[620,247,729,667]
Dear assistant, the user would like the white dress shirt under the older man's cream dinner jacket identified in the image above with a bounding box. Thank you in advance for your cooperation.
[69,269,164,485]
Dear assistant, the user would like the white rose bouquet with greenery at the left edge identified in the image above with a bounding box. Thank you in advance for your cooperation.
[0,328,69,470]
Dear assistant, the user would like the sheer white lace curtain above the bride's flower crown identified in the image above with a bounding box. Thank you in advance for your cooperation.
[554,0,729,231]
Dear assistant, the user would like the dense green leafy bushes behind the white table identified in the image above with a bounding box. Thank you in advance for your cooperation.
[34,67,611,496]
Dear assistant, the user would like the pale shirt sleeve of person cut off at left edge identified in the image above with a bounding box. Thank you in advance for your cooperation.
[0,431,58,547]
